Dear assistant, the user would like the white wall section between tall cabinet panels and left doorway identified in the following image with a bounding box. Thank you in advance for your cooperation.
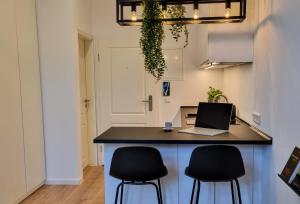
[37,0,91,184]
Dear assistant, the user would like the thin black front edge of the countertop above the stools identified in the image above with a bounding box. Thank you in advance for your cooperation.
[94,139,273,145]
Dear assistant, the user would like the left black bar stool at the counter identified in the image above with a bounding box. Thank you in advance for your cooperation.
[109,147,168,204]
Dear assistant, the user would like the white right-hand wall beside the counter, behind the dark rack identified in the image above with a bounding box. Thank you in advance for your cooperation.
[224,0,300,204]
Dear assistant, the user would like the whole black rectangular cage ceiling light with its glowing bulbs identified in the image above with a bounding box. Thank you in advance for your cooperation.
[116,0,246,26]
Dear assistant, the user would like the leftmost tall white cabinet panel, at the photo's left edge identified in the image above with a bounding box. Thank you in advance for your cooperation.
[0,0,26,204]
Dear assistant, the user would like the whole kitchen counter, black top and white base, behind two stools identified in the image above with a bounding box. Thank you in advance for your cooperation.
[94,118,272,204]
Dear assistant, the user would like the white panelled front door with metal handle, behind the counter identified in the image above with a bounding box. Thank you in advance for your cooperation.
[110,48,159,126]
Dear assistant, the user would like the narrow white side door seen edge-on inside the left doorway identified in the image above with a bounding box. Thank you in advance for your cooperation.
[79,38,89,168]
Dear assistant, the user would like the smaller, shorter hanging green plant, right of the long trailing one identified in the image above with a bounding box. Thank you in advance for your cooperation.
[167,4,189,47]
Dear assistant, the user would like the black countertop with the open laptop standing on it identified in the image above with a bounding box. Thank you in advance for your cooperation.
[94,121,272,145]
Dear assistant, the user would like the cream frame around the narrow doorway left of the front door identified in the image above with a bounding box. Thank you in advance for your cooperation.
[77,30,99,166]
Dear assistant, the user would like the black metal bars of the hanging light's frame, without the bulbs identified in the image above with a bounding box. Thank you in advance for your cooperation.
[116,0,247,26]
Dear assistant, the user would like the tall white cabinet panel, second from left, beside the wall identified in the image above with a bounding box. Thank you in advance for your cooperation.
[15,0,45,191]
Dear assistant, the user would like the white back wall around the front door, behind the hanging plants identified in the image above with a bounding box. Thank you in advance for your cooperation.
[92,0,223,133]
